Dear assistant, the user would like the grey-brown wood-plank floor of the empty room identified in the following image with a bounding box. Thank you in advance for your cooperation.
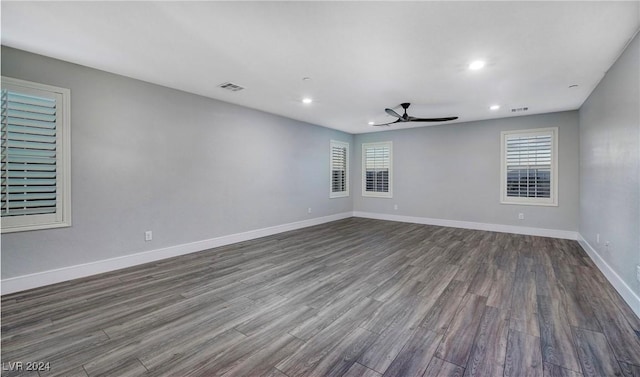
[2,218,640,377]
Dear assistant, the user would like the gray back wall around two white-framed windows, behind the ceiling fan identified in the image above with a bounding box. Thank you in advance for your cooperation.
[351,111,579,231]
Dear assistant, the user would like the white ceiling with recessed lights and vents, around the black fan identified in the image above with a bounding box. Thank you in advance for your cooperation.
[2,1,640,133]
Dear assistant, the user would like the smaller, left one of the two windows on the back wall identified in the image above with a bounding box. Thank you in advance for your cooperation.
[362,141,393,198]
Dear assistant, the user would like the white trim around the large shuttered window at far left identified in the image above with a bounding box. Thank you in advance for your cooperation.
[0,76,71,234]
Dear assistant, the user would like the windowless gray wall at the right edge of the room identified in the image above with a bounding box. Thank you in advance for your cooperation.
[580,35,640,295]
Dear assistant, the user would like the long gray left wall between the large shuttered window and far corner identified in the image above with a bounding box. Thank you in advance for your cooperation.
[2,47,353,279]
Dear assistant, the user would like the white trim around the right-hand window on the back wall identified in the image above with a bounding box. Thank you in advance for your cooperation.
[500,127,558,207]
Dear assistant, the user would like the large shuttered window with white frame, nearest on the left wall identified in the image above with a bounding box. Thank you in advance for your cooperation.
[0,77,71,233]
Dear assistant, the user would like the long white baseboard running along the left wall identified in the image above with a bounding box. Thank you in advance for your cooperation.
[0,212,353,295]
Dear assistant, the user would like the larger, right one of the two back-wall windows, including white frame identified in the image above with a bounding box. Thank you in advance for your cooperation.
[500,127,558,206]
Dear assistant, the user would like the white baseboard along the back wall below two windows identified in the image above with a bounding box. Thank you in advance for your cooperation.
[353,211,578,240]
